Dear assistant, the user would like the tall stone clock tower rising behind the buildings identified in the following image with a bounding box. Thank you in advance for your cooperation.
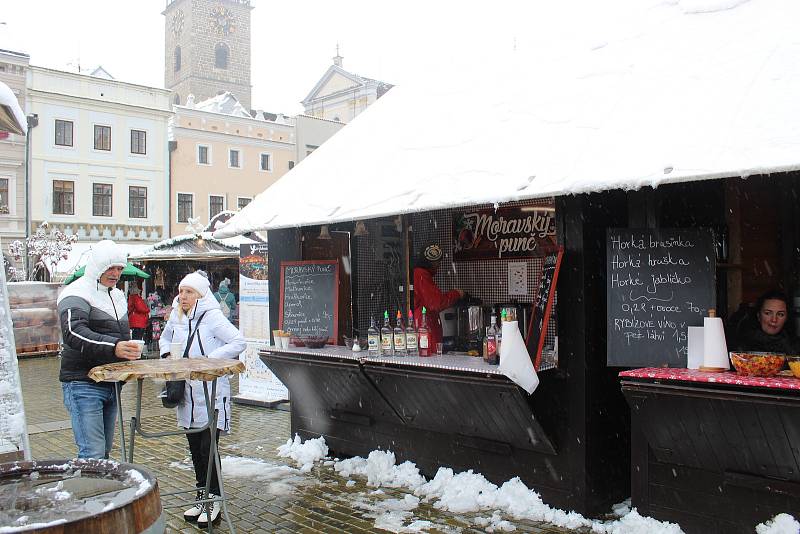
[162,0,252,110]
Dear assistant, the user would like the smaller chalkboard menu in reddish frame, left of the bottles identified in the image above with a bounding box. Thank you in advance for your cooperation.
[279,260,339,343]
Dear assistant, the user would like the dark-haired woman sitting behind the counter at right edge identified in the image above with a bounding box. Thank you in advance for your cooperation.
[739,291,800,354]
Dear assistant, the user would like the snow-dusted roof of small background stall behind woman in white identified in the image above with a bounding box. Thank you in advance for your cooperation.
[128,232,255,262]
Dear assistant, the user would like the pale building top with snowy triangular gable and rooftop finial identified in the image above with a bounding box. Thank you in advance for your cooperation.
[301,50,392,123]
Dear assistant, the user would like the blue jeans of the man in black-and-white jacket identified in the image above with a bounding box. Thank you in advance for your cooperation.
[61,380,117,458]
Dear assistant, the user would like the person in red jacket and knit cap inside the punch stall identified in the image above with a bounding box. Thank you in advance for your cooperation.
[414,244,464,347]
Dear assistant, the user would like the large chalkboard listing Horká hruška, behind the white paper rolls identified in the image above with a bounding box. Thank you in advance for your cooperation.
[606,228,716,367]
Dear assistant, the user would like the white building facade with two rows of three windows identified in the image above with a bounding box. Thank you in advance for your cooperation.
[27,67,171,249]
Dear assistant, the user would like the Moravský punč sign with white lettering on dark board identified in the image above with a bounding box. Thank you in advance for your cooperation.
[453,206,558,261]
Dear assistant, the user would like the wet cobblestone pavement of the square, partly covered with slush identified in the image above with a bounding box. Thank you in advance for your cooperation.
[20,357,580,534]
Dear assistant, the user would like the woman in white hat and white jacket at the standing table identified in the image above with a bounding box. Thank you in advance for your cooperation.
[159,272,246,527]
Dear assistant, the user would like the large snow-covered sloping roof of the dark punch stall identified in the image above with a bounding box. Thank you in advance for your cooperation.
[215,0,800,236]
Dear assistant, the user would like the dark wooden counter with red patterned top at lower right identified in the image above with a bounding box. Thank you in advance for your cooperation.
[620,368,800,534]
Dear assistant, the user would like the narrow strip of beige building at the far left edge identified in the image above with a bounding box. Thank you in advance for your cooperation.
[0,50,30,243]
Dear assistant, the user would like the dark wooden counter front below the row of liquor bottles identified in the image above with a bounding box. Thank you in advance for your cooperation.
[260,347,574,506]
